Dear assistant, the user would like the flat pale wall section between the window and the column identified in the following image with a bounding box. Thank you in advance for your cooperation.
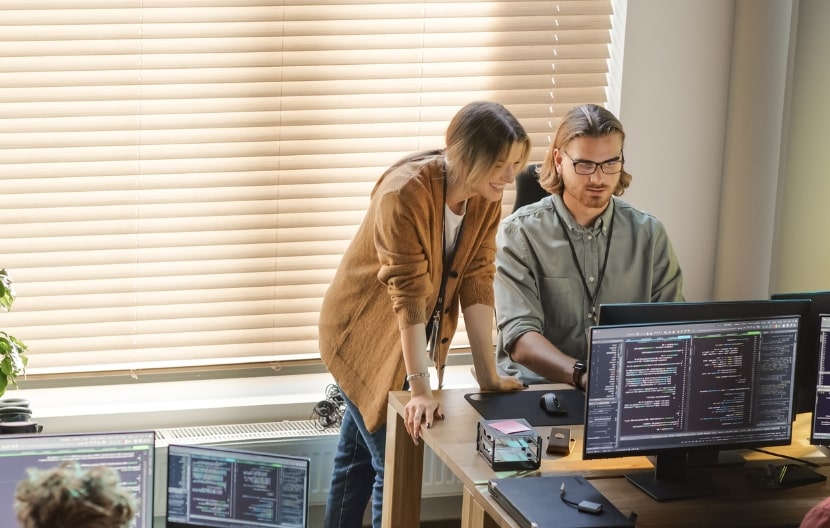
[619,0,733,300]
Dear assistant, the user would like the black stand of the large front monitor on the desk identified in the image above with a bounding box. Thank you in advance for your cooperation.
[625,453,712,501]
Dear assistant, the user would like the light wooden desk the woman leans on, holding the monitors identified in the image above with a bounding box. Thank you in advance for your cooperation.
[383,385,830,528]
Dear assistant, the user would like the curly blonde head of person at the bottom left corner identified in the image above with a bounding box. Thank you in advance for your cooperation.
[15,462,136,528]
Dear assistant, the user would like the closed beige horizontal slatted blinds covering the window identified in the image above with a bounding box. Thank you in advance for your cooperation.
[0,0,611,376]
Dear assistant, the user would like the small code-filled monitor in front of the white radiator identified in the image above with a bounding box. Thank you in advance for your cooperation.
[167,445,310,528]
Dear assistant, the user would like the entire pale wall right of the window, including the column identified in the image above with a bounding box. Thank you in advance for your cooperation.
[619,0,830,300]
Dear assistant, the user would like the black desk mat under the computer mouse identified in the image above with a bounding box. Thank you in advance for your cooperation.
[464,386,585,427]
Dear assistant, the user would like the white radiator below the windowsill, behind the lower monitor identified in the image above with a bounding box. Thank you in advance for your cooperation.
[154,420,461,516]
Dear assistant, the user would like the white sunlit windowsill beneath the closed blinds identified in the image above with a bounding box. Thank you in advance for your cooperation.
[4,363,478,433]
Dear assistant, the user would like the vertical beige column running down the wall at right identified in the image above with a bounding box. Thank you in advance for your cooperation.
[715,0,797,298]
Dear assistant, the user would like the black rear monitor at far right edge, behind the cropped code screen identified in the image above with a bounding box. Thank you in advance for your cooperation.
[771,291,830,413]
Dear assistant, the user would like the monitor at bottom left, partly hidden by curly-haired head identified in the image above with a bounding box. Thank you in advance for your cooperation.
[0,431,155,528]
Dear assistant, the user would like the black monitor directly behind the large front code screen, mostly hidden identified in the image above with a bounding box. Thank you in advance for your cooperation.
[599,297,812,419]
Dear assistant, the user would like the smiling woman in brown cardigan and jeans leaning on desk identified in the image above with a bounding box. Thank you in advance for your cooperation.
[319,102,530,528]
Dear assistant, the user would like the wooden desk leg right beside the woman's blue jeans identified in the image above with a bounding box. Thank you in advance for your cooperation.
[382,406,424,528]
